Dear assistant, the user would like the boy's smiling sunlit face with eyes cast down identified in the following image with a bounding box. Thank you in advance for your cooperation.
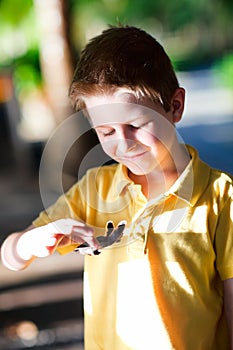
[85,88,184,175]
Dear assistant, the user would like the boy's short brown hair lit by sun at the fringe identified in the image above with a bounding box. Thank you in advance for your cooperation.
[69,26,179,111]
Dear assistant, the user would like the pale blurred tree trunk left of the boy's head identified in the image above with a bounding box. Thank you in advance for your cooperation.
[34,0,73,124]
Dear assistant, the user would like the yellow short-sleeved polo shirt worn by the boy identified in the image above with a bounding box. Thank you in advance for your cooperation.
[34,146,233,350]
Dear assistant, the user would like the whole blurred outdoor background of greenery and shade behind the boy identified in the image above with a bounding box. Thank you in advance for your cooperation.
[0,0,233,350]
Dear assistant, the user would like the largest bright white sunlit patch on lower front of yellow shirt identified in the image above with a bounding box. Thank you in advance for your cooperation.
[116,259,171,350]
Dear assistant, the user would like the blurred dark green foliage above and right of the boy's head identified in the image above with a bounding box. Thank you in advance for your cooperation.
[70,0,233,70]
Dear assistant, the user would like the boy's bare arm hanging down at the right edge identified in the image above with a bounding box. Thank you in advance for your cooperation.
[224,278,233,350]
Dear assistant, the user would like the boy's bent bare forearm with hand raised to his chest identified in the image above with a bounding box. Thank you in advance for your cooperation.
[1,219,99,271]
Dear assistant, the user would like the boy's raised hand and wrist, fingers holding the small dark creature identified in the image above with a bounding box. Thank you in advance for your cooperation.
[17,219,99,260]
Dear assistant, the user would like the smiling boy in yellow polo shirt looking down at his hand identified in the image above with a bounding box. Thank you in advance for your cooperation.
[2,26,233,350]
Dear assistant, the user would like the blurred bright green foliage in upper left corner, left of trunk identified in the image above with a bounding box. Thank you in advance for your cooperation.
[0,0,41,93]
